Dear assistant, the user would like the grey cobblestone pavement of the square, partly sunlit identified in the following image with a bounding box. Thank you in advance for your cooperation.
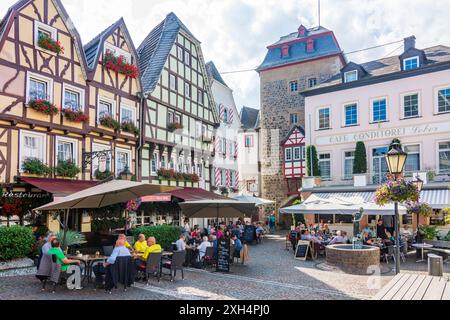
[0,232,450,300]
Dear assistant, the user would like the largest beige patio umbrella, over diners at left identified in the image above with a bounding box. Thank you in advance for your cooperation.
[34,180,176,211]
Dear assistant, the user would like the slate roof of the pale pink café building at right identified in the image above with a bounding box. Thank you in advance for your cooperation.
[305,45,450,92]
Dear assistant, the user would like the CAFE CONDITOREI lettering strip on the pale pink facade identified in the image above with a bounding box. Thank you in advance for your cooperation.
[316,122,450,146]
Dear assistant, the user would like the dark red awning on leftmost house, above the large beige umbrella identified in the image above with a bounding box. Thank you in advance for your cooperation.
[19,177,98,197]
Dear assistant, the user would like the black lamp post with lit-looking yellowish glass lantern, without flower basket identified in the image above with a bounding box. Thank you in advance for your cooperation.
[386,143,408,274]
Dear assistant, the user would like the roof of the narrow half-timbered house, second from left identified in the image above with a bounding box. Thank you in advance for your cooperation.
[84,18,140,85]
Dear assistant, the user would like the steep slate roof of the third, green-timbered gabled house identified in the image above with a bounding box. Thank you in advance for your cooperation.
[137,12,200,93]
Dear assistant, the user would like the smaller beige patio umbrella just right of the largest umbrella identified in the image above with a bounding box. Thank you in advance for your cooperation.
[178,200,255,220]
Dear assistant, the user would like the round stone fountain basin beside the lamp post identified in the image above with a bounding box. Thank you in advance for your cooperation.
[326,244,380,275]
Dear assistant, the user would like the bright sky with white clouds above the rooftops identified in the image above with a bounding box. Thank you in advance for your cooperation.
[0,0,450,109]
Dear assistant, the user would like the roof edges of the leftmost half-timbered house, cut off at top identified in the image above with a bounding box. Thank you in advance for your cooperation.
[0,0,88,79]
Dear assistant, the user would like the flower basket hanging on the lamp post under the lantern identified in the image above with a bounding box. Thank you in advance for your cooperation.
[375,180,420,206]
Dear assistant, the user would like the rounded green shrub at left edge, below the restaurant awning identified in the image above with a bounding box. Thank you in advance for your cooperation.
[0,226,36,261]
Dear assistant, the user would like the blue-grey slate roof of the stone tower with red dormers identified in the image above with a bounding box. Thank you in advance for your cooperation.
[256,27,342,72]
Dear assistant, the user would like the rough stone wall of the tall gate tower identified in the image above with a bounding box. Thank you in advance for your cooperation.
[260,57,342,220]
